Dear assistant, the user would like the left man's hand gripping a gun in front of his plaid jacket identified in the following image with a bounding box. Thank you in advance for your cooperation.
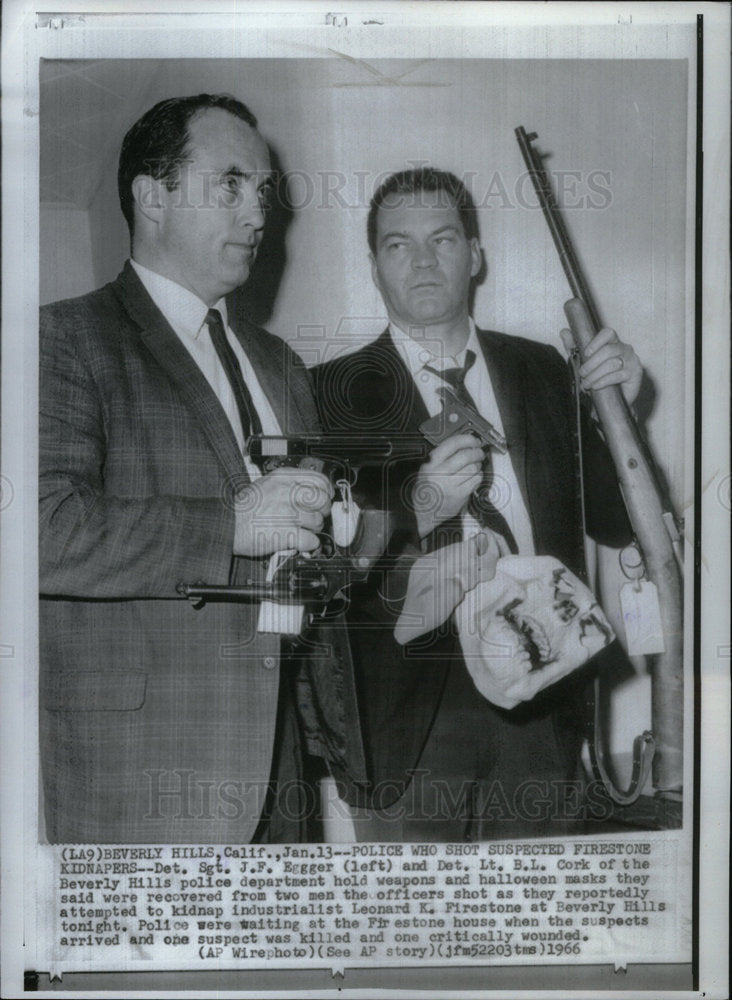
[234,467,333,558]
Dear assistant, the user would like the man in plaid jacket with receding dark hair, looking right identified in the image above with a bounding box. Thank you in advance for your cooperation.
[40,94,360,843]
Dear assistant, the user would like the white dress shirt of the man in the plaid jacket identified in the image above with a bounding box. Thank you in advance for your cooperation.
[130,260,282,479]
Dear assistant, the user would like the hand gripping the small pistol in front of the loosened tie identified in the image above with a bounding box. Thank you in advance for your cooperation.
[412,434,485,538]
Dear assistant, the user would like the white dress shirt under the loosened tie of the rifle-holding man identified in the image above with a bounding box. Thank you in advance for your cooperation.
[389,317,535,555]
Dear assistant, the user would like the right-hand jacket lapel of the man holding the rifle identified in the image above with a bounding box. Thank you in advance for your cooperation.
[478,330,534,524]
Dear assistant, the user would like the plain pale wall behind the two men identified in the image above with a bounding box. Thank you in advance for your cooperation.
[40,55,688,772]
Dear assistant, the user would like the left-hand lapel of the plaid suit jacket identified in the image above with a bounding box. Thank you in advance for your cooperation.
[114,262,249,482]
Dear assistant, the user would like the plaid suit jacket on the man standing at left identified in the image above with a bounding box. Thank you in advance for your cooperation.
[40,264,359,843]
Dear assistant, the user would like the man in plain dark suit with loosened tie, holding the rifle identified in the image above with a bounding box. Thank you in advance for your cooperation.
[317,168,641,840]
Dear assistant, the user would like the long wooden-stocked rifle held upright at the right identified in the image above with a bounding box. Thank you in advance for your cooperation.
[515,126,683,811]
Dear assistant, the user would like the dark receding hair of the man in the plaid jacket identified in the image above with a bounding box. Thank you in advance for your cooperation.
[117,94,257,236]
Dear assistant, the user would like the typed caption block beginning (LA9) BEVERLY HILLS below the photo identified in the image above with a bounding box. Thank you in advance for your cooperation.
[36,835,690,973]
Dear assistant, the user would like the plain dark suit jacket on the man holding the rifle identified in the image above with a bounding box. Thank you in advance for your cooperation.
[314,331,629,805]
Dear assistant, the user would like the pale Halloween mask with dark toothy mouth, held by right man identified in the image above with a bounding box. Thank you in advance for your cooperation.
[456,556,615,708]
